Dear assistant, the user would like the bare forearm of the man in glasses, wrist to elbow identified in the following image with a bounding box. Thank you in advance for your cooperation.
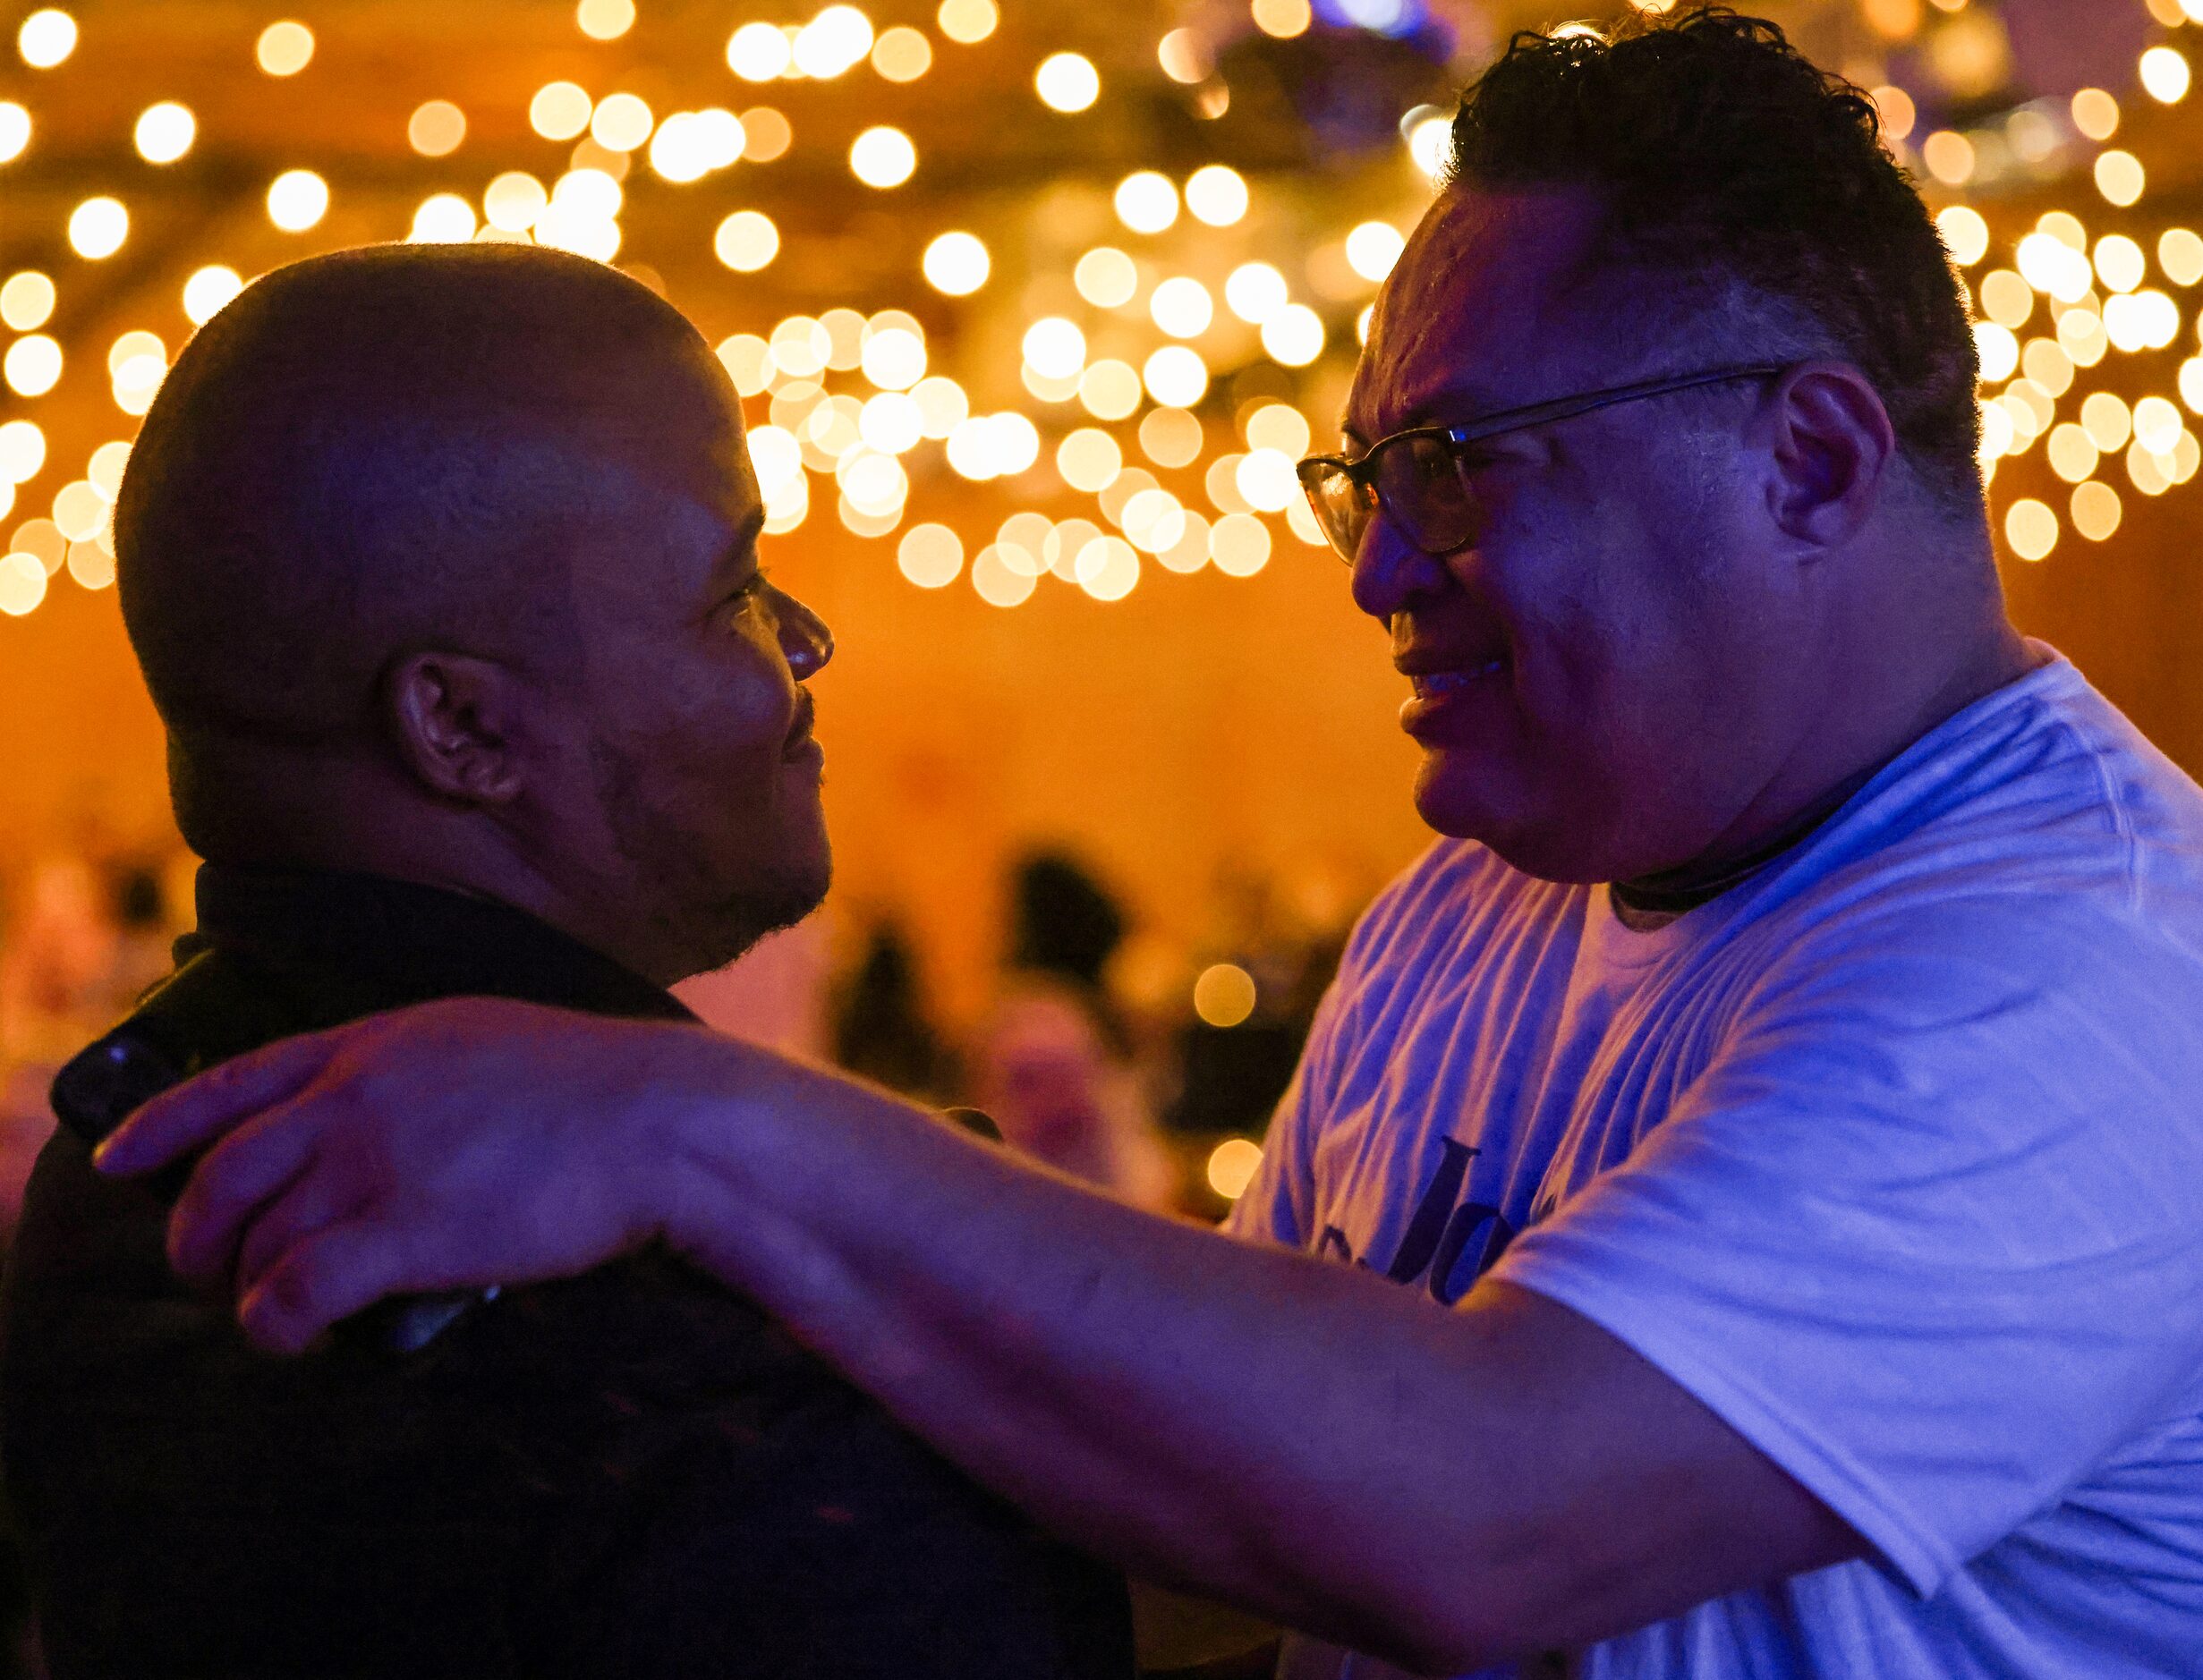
[651,1052,1568,1651]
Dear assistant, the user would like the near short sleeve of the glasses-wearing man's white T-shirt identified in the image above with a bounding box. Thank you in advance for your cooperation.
[1493,901,2203,1596]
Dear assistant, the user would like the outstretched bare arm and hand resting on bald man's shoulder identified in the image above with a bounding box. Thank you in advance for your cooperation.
[101,1002,1861,1674]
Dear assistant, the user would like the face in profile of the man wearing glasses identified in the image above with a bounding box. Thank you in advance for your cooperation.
[1346,185,1797,881]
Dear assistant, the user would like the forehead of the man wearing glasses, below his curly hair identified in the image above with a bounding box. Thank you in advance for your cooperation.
[1346,187,1599,438]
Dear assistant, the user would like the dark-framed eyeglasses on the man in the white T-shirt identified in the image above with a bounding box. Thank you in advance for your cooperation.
[1297,363,1787,566]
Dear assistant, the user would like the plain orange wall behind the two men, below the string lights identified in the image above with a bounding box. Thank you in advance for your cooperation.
[13,466,2203,1030]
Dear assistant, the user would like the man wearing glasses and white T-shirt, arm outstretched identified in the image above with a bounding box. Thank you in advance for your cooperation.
[86,13,2203,1680]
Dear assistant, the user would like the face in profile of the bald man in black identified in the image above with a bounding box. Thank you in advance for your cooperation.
[542,348,833,973]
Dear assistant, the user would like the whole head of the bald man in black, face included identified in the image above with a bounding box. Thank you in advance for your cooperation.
[115,244,830,978]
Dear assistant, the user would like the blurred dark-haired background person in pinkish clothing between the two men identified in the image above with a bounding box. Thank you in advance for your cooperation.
[972,853,1178,1211]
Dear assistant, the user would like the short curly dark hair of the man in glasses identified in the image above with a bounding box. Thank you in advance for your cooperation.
[1448,6,1980,509]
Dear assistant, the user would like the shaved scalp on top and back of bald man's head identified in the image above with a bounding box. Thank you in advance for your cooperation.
[115,244,710,836]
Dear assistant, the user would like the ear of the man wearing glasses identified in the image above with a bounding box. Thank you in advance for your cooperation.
[1763,361,1897,548]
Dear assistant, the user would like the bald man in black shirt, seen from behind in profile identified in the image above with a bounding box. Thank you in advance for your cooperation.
[0,247,1130,1680]
